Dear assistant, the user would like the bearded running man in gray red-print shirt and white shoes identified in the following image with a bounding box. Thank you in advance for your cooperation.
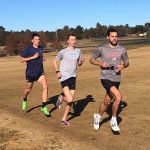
[90,29,129,131]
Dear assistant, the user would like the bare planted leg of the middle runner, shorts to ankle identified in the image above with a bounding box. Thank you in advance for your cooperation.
[62,86,74,121]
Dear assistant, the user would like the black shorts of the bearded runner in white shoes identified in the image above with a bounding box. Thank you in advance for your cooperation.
[101,79,120,93]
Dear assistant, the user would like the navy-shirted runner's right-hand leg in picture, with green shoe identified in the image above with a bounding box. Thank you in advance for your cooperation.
[38,75,50,115]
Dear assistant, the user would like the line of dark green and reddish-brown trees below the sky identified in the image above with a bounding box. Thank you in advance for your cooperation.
[0,22,150,55]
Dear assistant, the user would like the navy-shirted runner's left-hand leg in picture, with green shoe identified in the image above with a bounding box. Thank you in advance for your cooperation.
[22,82,33,110]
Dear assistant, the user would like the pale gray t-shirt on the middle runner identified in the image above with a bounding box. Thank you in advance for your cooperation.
[55,48,82,82]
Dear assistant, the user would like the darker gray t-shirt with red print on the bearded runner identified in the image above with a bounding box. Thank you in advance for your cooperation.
[92,44,128,82]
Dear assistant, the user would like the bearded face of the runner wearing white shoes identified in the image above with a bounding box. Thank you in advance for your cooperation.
[107,32,118,46]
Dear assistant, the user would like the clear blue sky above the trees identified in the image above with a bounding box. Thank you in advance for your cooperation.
[0,0,150,31]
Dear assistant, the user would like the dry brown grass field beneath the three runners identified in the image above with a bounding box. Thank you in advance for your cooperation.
[0,47,150,150]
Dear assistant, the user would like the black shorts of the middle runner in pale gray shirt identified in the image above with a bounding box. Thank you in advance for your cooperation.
[61,77,76,90]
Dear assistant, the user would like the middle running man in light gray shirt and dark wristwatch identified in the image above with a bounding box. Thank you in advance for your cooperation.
[53,34,84,125]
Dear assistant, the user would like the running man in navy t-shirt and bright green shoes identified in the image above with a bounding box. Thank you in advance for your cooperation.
[20,34,50,116]
